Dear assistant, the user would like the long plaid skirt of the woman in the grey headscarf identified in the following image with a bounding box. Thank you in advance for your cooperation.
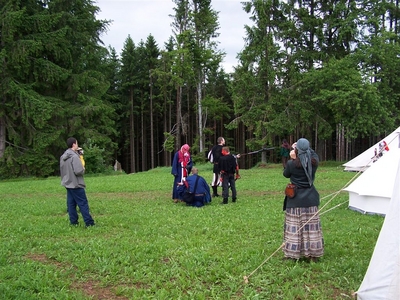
[283,206,324,259]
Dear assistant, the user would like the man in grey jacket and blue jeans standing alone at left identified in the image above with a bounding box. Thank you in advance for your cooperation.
[60,137,94,227]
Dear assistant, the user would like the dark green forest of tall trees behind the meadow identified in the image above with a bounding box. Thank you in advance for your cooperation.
[0,0,400,178]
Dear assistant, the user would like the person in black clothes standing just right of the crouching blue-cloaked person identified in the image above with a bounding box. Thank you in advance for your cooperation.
[218,147,238,204]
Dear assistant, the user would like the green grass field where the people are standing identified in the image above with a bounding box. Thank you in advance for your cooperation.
[0,163,383,300]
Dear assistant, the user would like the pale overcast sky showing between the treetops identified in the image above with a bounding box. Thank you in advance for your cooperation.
[95,0,252,73]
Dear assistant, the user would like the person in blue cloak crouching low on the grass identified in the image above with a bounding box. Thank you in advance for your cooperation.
[180,167,211,207]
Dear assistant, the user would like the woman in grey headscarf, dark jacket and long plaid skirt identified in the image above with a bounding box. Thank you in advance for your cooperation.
[283,138,324,260]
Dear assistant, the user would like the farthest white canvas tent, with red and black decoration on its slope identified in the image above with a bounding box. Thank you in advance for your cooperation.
[343,127,400,172]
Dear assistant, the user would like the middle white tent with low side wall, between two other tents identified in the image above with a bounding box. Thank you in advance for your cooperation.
[344,148,400,215]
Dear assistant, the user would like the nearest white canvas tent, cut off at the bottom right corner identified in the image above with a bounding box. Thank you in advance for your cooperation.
[356,156,400,300]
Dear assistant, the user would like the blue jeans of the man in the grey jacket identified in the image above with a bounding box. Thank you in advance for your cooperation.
[67,188,94,226]
